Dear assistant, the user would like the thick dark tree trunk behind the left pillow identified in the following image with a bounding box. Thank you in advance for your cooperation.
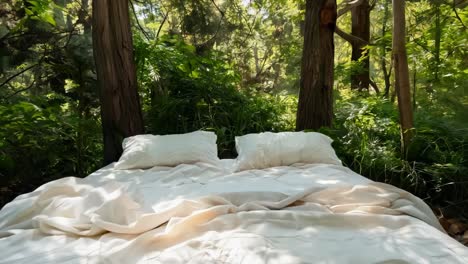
[92,0,144,164]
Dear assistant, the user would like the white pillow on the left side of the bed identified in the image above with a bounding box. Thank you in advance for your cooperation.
[114,131,219,170]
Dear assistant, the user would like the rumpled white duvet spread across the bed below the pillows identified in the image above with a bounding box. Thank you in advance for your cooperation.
[0,162,468,264]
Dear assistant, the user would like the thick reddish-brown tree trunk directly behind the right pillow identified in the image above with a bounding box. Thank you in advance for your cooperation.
[296,0,337,131]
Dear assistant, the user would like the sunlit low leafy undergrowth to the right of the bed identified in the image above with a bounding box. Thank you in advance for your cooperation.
[322,93,468,214]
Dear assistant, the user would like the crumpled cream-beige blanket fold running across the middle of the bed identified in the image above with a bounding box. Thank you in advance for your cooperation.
[0,178,443,236]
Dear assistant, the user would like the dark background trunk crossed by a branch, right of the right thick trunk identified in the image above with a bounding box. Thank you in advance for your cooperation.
[351,0,371,90]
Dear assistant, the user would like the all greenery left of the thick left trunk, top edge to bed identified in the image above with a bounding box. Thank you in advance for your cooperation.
[0,0,102,206]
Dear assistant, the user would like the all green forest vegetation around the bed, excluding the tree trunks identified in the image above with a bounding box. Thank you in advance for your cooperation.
[0,0,468,218]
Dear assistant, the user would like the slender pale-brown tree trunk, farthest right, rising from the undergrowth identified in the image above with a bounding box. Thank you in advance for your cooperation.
[393,0,413,156]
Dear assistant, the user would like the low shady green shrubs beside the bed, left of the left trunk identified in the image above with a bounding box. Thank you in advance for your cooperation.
[0,98,101,192]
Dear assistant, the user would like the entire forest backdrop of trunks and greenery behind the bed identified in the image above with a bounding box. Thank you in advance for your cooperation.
[0,0,468,232]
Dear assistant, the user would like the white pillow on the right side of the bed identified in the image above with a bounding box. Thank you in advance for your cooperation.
[236,132,341,170]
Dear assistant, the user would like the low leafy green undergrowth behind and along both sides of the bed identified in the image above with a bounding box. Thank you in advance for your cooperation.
[0,36,468,219]
